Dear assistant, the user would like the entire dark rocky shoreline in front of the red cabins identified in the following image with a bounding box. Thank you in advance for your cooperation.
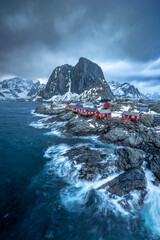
[35,105,160,210]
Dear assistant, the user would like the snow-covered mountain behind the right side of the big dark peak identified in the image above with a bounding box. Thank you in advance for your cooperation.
[108,81,146,99]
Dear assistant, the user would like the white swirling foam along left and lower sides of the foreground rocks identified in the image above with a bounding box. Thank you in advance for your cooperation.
[44,141,131,214]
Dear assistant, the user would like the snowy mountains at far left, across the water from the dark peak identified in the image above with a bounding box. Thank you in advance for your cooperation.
[0,77,45,100]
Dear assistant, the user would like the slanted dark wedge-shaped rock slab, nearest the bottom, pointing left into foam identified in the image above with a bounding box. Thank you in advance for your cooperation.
[101,168,146,197]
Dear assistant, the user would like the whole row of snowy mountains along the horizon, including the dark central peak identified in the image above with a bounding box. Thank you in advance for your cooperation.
[0,61,155,101]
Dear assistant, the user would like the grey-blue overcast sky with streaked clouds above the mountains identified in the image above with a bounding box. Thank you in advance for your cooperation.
[0,0,160,93]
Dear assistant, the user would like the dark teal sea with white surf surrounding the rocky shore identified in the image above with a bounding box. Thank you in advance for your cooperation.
[0,102,160,240]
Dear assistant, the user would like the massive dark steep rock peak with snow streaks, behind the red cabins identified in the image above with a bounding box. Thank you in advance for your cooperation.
[32,57,114,101]
